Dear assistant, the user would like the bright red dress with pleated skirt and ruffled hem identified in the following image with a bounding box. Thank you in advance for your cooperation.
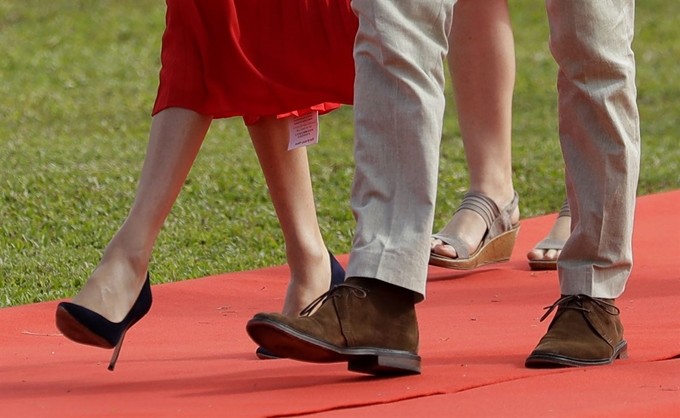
[153,0,358,122]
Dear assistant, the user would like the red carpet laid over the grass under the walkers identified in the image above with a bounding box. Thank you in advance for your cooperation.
[0,191,680,418]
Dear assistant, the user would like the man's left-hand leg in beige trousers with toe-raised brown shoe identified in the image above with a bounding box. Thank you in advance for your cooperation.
[246,0,454,375]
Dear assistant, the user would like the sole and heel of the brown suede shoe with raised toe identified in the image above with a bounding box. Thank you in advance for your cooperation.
[246,318,421,376]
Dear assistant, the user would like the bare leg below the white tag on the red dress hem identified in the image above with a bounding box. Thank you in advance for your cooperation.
[248,117,331,316]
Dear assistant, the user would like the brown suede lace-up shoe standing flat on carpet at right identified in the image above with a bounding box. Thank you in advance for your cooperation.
[524,295,628,368]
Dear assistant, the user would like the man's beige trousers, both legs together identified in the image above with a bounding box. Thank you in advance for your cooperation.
[347,0,639,299]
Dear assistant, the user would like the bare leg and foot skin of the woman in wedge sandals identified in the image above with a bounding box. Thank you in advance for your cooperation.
[431,0,519,258]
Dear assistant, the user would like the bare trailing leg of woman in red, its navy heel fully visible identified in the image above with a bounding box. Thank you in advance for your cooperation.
[73,108,212,322]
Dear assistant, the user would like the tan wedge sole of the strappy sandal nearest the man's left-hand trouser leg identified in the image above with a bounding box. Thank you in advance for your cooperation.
[430,225,519,270]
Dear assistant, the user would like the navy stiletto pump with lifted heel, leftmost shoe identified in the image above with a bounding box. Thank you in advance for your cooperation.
[56,272,153,371]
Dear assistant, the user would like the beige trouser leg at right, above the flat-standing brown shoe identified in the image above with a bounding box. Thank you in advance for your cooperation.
[546,0,640,298]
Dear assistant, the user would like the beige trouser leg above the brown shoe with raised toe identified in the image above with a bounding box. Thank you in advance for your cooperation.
[347,0,455,299]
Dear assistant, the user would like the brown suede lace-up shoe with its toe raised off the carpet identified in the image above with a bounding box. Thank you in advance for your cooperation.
[246,277,420,375]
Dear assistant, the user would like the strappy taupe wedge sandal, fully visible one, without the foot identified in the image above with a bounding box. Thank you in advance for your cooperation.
[430,192,519,270]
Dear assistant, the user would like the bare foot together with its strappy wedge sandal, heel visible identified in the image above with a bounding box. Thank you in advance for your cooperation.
[430,192,519,270]
